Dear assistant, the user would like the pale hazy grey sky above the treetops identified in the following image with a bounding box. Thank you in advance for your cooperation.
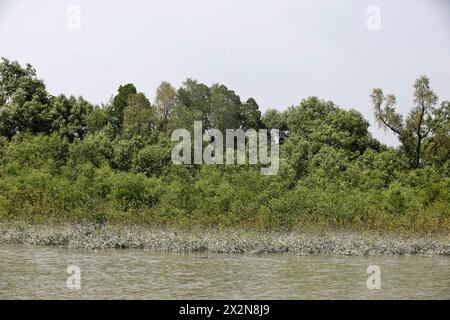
[0,0,450,144]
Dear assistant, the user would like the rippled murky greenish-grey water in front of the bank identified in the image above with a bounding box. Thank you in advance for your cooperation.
[0,245,450,299]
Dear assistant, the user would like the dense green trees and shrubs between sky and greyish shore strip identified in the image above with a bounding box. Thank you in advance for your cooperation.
[0,59,450,232]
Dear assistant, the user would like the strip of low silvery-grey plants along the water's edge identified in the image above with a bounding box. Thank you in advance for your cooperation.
[0,222,450,256]
